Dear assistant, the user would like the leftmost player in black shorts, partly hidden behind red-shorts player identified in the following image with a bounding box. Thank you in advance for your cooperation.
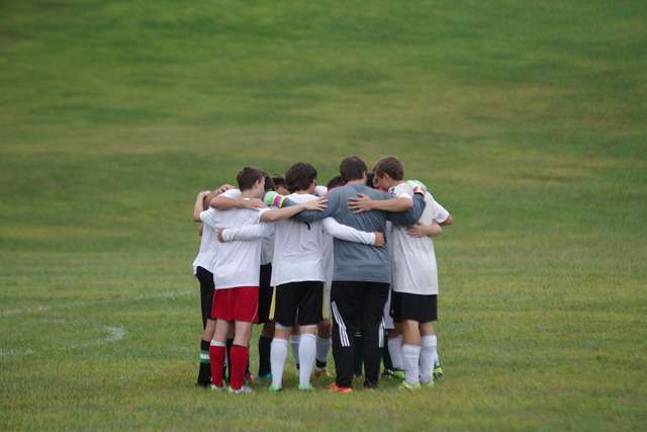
[193,184,231,387]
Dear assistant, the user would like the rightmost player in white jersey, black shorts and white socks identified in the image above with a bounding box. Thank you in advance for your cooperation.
[351,157,452,390]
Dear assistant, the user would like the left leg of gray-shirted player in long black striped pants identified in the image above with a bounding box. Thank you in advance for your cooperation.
[330,281,362,391]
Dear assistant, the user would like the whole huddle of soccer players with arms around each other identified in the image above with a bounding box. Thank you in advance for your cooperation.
[193,156,452,394]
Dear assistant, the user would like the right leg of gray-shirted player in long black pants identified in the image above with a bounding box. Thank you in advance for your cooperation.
[361,282,389,388]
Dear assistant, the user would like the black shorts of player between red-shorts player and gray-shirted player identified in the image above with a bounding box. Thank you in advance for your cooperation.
[274,281,323,327]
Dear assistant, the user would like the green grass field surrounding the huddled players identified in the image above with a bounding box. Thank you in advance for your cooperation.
[0,0,647,431]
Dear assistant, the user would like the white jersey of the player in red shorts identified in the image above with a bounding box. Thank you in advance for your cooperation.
[200,205,267,289]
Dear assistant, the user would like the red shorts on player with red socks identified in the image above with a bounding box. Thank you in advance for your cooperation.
[211,287,258,322]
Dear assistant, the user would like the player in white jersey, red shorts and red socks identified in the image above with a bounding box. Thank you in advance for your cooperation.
[200,167,325,393]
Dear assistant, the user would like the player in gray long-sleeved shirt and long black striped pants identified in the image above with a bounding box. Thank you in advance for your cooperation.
[295,156,425,393]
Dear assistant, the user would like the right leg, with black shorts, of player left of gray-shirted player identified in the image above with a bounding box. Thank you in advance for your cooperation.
[297,281,323,390]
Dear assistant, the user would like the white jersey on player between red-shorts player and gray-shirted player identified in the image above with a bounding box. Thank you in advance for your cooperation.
[272,193,326,286]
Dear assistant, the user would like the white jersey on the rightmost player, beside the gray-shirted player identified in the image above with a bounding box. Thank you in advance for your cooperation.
[389,183,449,295]
